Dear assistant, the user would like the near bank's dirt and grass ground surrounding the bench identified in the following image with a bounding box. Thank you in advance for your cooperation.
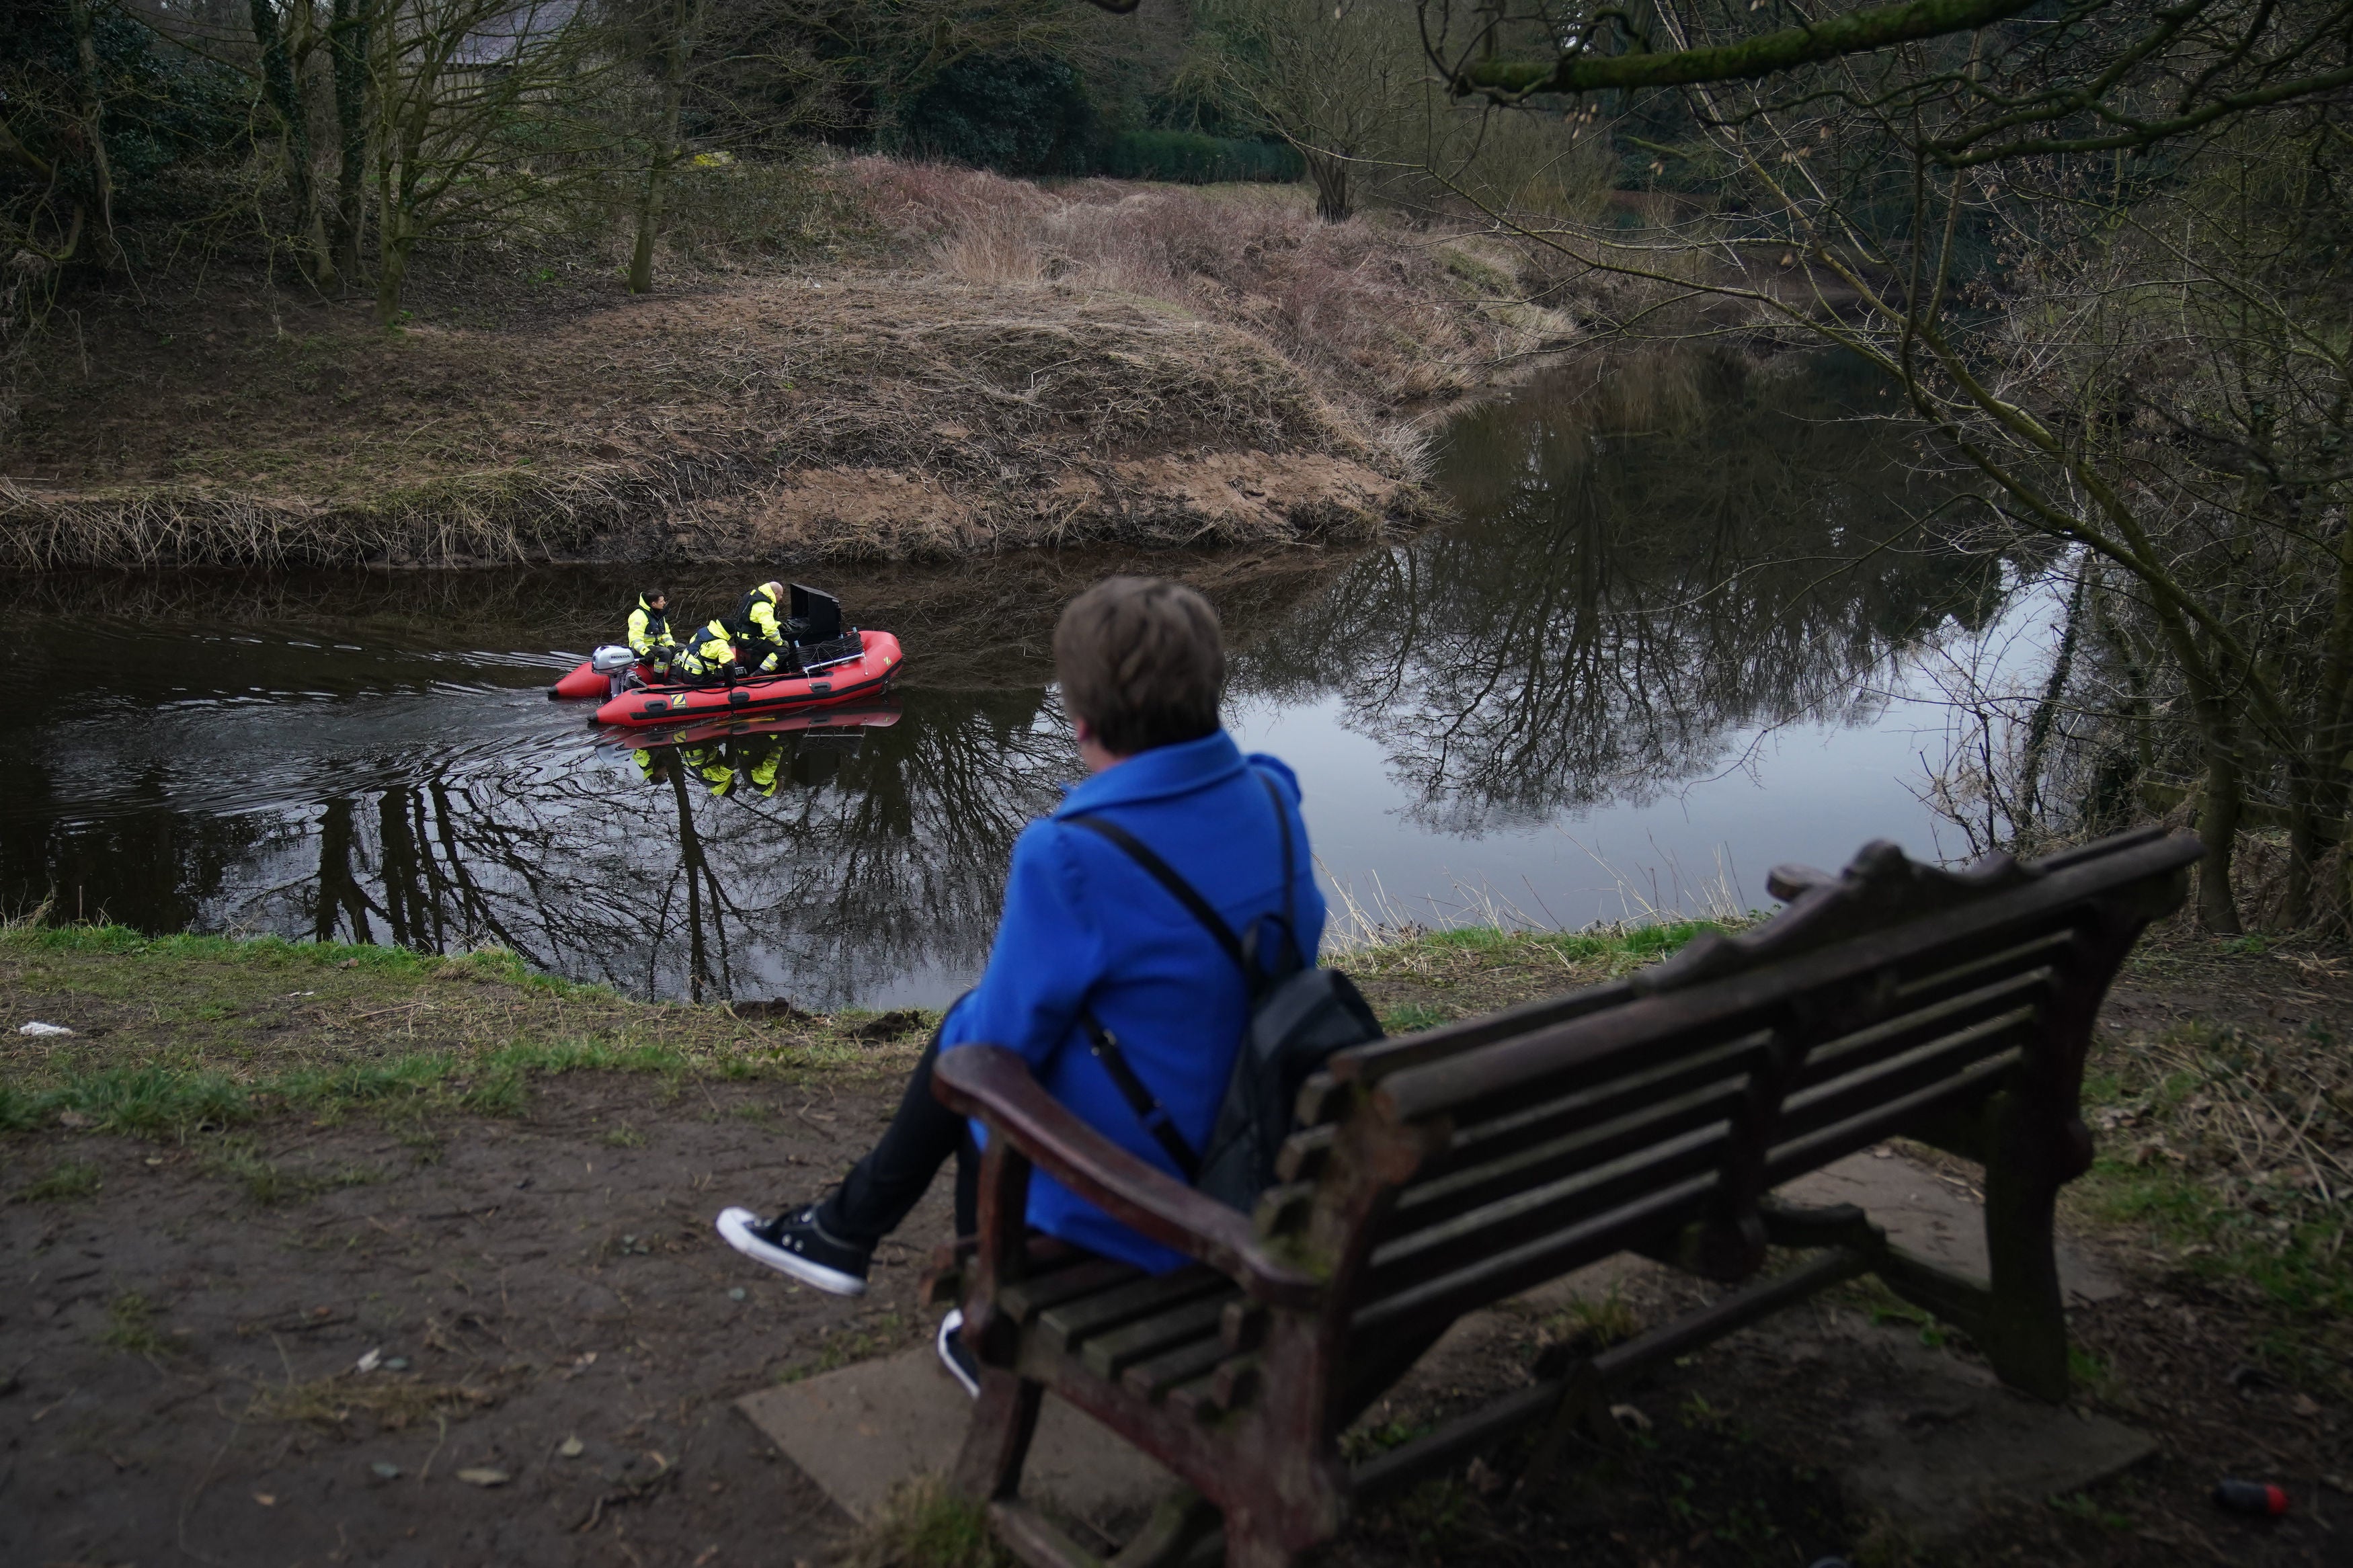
[0,924,2353,1566]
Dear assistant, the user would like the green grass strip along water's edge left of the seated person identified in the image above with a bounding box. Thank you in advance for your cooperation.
[0,921,916,1138]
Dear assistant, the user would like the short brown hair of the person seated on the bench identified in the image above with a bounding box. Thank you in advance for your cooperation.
[1054,576,1226,757]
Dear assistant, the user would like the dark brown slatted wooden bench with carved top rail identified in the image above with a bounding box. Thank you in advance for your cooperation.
[936,830,2200,1568]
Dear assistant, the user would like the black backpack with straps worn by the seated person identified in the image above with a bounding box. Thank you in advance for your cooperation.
[1062,774,1382,1213]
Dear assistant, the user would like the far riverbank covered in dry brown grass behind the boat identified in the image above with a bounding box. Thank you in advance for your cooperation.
[0,157,1574,569]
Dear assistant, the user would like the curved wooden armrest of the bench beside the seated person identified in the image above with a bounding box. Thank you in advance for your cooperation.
[932,1046,1322,1307]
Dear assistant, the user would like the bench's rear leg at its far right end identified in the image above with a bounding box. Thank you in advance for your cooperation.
[1984,1093,2069,1403]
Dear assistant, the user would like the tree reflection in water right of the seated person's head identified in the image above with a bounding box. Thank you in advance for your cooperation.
[1238,355,2003,835]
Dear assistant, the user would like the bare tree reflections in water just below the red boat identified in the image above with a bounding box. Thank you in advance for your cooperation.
[257,689,1076,1006]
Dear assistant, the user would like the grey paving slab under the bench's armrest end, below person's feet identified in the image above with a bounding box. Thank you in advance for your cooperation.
[737,1347,1176,1540]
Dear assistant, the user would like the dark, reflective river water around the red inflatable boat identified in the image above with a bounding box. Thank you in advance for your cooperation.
[0,360,2012,1009]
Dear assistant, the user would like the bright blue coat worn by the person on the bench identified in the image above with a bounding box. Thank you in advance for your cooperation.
[939,731,1325,1272]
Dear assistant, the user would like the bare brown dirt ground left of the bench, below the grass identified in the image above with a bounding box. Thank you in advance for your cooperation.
[0,1074,946,1566]
